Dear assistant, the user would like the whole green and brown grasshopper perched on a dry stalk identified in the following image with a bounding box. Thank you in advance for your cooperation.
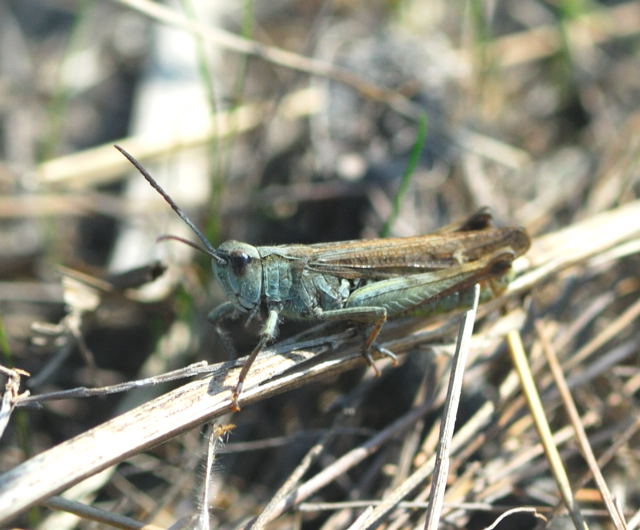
[115,145,530,410]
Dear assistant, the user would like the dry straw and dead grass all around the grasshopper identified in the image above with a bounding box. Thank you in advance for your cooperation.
[0,0,640,529]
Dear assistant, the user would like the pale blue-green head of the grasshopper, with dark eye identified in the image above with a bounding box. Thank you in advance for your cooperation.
[212,241,262,311]
